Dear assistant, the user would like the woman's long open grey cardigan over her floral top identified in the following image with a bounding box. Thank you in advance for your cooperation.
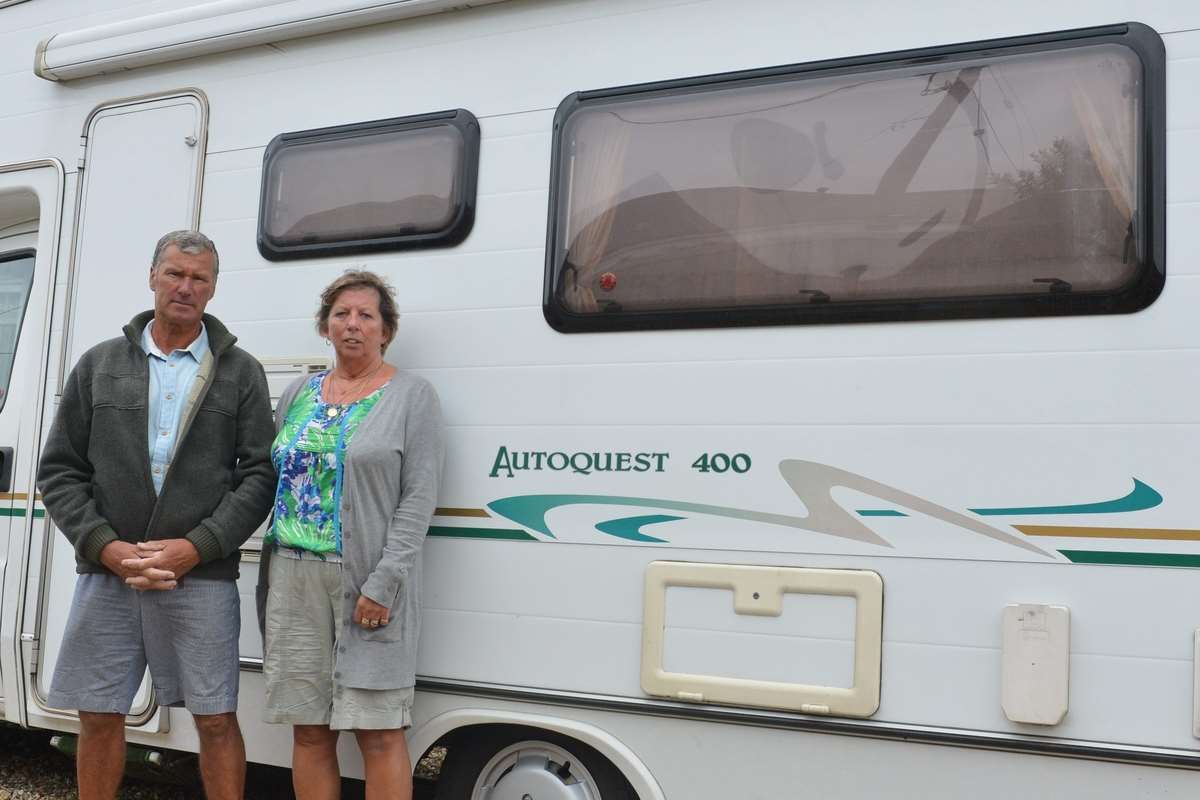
[257,372,445,688]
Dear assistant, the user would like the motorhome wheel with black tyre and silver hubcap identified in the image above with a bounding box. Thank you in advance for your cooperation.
[437,726,637,800]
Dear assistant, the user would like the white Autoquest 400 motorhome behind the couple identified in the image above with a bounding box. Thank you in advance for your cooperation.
[0,0,1200,800]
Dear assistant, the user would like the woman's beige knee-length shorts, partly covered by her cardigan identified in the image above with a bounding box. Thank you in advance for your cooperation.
[263,549,413,730]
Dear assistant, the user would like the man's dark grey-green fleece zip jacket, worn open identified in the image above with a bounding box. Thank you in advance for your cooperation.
[37,311,275,579]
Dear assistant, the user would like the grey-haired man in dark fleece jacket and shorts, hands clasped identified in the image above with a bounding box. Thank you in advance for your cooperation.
[37,230,275,800]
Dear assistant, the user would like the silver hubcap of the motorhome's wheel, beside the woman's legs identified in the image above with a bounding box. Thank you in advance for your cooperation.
[470,741,601,800]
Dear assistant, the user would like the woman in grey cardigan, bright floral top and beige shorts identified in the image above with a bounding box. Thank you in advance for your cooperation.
[259,271,443,800]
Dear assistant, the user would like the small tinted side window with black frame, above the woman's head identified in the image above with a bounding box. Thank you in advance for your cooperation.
[258,110,479,260]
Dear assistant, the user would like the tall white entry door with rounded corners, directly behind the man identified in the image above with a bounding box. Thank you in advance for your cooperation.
[35,90,208,732]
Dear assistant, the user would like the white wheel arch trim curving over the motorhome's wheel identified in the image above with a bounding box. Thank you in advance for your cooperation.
[408,708,666,800]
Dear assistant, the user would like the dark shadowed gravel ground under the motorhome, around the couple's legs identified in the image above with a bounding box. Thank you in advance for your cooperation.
[0,723,445,800]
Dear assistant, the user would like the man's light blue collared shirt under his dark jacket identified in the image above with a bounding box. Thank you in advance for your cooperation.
[142,319,209,494]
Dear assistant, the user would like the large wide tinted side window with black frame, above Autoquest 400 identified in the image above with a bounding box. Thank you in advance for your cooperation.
[545,25,1164,331]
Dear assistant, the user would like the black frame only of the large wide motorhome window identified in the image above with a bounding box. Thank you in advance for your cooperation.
[542,22,1166,333]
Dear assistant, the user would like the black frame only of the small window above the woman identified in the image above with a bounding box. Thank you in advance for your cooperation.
[257,108,480,261]
